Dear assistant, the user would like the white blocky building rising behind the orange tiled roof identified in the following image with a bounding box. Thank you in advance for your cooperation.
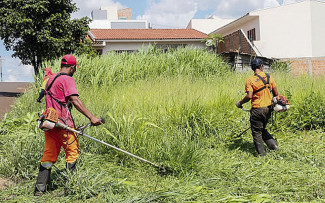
[89,6,150,29]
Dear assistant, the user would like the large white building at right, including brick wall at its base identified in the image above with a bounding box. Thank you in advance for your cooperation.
[212,0,325,74]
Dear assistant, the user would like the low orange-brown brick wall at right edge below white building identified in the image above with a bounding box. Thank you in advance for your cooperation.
[282,57,325,76]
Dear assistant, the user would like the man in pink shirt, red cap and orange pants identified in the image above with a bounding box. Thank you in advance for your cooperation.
[34,55,102,196]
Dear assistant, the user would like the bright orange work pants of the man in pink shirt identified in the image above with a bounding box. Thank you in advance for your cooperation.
[41,128,79,164]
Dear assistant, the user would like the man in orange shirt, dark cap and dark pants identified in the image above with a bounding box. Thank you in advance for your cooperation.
[236,59,279,156]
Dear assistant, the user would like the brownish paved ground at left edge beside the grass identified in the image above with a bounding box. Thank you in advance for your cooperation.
[0,82,30,120]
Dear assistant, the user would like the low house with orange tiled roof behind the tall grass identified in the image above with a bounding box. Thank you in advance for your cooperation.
[88,29,208,54]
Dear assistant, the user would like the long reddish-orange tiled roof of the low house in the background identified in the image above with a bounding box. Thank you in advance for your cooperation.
[88,29,209,41]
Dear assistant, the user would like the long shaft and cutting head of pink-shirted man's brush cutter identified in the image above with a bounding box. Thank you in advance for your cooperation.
[55,118,173,175]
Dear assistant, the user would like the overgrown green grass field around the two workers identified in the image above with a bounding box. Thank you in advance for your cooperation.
[0,48,325,202]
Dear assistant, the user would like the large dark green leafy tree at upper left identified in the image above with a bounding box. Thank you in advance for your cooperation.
[0,0,90,75]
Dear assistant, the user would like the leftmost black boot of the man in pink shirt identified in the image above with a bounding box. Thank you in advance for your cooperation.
[34,165,51,196]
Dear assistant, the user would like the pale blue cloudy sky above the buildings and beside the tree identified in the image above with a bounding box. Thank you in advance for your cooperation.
[0,0,306,81]
